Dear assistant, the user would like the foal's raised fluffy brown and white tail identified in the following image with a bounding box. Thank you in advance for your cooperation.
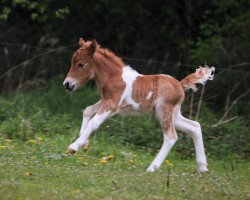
[180,66,215,91]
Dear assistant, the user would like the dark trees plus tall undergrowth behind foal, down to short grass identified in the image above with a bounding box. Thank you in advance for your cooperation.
[0,0,250,158]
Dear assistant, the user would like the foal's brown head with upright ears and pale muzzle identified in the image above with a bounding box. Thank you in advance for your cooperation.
[63,38,97,91]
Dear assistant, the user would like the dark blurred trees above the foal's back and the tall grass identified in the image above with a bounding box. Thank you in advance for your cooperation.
[0,0,250,112]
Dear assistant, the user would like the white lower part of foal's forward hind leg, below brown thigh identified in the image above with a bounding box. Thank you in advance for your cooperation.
[147,134,177,172]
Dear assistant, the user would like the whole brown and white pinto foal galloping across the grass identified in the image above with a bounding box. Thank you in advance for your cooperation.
[63,38,215,172]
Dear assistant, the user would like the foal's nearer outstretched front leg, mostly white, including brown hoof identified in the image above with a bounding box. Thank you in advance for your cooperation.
[68,104,114,153]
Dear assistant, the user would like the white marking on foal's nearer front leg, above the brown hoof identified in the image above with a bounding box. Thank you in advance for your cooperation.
[69,111,111,151]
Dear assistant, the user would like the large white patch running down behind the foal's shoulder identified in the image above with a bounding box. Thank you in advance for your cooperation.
[119,66,142,110]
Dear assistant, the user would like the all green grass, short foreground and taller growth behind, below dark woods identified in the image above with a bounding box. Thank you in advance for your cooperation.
[0,77,250,200]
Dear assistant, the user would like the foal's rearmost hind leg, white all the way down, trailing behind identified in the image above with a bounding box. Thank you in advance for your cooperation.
[174,109,208,172]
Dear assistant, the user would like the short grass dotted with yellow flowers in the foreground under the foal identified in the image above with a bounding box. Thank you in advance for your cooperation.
[0,132,250,200]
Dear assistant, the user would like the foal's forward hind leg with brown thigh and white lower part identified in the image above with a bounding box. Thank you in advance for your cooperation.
[147,105,178,172]
